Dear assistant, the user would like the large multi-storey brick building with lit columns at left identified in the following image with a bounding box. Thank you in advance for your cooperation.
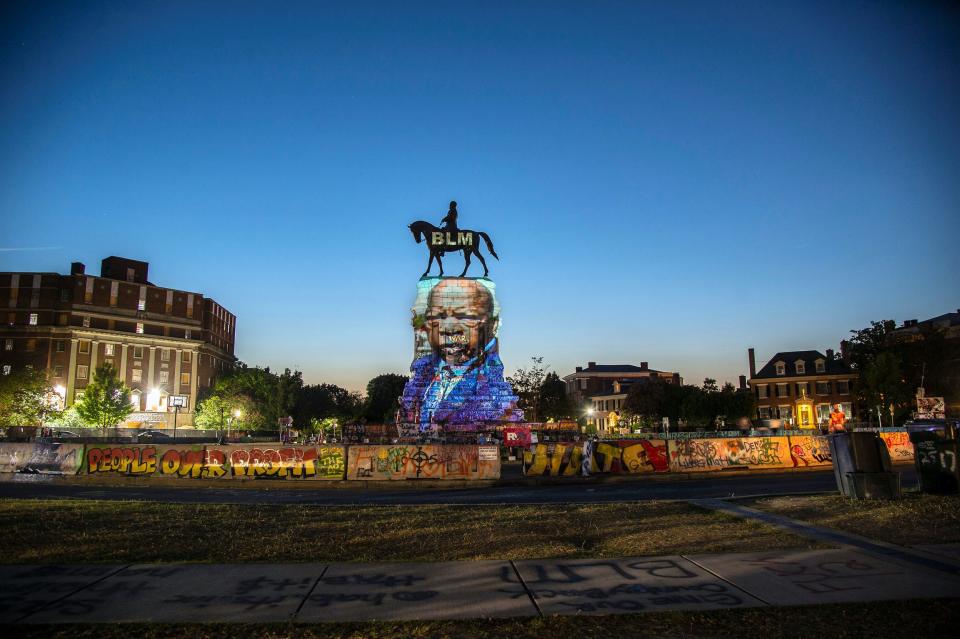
[0,257,237,426]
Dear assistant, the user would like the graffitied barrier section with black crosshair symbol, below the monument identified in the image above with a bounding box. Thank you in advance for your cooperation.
[347,444,500,481]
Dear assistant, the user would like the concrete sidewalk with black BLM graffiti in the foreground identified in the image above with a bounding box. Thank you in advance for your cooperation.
[7,547,960,623]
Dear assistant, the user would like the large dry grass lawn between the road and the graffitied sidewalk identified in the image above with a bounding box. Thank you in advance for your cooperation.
[0,500,822,564]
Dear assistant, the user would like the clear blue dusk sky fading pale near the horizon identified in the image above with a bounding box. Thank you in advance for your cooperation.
[0,0,960,389]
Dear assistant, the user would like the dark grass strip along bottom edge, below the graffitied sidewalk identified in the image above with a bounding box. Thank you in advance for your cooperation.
[15,600,960,639]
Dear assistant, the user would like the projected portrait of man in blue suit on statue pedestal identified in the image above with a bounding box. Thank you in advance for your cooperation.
[402,278,522,430]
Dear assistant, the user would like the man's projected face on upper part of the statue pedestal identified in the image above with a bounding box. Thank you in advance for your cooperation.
[424,280,496,366]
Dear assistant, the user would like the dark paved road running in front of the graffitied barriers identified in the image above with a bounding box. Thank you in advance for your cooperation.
[0,467,916,505]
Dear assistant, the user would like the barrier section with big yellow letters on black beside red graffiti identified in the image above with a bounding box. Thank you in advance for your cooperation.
[523,439,670,476]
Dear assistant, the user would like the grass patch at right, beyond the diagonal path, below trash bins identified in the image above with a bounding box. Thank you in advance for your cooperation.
[737,493,960,546]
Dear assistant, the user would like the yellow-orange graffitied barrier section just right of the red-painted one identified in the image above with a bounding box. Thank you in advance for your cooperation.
[669,437,793,473]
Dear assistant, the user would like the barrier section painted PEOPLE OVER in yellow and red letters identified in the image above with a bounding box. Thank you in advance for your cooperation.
[83,444,345,480]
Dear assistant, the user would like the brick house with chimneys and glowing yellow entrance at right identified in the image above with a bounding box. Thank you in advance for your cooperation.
[747,348,857,428]
